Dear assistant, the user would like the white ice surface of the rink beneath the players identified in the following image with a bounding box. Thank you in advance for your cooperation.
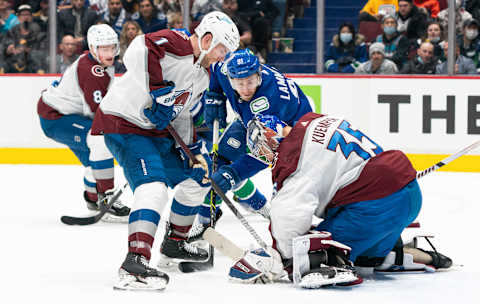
[0,165,480,304]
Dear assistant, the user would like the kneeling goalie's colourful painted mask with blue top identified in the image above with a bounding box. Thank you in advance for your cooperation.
[247,114,287,165]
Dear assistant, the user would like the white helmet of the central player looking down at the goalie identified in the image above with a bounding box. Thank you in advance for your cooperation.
[195,11,240,62]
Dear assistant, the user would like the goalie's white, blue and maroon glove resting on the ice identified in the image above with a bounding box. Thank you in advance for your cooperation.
[228,247,285,284]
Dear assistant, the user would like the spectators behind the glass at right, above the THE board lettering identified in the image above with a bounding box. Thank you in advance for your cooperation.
[325,0,480,74]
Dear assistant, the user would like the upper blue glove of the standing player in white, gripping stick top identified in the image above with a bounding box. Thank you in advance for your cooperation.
[203,91,227,130]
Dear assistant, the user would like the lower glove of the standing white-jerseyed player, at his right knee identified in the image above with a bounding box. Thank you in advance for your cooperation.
[178,142,212,187]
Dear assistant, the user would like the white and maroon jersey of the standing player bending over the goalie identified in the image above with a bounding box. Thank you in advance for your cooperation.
[92,30,209,144]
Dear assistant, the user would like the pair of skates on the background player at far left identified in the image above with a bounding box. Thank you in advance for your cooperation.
[83,191,130,223]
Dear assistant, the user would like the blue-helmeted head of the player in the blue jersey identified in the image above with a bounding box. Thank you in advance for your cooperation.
[226,49,262,101]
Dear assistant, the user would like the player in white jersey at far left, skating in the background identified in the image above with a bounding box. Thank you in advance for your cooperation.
[37,24,130,222]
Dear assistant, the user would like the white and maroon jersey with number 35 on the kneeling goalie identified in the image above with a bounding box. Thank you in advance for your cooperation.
[271,113,416,258]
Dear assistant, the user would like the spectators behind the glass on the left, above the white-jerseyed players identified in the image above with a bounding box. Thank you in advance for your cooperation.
[0,0,309,73]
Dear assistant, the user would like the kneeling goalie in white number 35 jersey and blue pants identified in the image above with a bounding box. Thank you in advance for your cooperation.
[230,113,452,288]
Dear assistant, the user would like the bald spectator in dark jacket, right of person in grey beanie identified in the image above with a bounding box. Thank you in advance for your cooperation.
[400,41,437,74]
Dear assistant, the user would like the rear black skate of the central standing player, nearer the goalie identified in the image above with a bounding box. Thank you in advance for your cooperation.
[158,225,208,268]
